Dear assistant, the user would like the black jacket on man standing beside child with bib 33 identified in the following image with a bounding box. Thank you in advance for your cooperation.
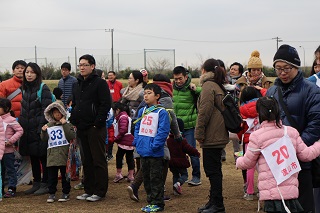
[70,71,111,130]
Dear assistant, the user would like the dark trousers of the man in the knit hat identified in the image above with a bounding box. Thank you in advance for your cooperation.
[298,169,315,212]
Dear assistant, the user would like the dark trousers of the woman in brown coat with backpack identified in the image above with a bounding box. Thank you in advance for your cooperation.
[202,148,224,207]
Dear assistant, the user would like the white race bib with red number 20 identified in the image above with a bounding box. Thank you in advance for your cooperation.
[261,126,301,185]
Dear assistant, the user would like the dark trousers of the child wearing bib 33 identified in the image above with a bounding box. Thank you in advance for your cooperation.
[47,166,71,194]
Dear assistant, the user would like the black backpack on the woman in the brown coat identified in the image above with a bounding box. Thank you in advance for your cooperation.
[216,93,242,133]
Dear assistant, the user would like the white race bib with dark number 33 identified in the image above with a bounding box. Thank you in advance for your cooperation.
[47,126,69,149]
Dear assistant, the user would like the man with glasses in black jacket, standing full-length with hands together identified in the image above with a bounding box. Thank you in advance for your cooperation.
[70,55,111,202]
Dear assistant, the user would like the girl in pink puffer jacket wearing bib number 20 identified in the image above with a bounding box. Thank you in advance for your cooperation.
[236,97,320,212]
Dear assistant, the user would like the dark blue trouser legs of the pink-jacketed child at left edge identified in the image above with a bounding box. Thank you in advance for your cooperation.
[2,153,17,189]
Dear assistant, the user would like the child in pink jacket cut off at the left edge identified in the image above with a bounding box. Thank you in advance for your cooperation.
[0,98,23,200]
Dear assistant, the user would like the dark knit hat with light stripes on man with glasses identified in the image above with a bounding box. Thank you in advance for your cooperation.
[273,44,301,67]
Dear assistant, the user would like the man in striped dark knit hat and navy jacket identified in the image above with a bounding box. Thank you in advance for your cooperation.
[267,44,320,212]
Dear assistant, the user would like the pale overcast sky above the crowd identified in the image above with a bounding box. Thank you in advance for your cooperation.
[0,0,320,71]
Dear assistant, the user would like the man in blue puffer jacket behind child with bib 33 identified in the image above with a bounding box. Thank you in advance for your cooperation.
[58,62,77,107]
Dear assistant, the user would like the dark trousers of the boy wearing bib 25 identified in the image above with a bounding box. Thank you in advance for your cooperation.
[140,157,164,208]
